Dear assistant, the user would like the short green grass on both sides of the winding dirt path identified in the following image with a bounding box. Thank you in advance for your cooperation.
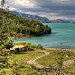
[0,49,75,75]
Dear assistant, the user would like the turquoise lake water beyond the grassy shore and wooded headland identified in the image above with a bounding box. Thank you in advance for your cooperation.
[13,23,75,49]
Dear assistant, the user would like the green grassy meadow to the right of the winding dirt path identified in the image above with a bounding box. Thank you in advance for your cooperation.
[37,50,75,72]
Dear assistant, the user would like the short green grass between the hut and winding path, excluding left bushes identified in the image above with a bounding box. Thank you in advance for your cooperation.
[1,50,44,75]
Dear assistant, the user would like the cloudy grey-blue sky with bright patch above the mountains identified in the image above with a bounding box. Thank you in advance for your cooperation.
[0,0,75,20]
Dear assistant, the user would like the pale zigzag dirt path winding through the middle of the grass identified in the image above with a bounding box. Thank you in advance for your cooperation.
[27,51,50,68]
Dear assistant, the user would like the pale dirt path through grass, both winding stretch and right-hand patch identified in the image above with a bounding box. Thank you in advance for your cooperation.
[27,51,74,68]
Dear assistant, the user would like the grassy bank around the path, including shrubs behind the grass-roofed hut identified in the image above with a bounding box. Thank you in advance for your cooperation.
[2,42,75,75]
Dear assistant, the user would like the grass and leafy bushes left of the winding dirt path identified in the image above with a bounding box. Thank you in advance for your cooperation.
[0,49,43,75]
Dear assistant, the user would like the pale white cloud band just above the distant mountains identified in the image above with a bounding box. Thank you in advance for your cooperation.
[22,12,75,20]
